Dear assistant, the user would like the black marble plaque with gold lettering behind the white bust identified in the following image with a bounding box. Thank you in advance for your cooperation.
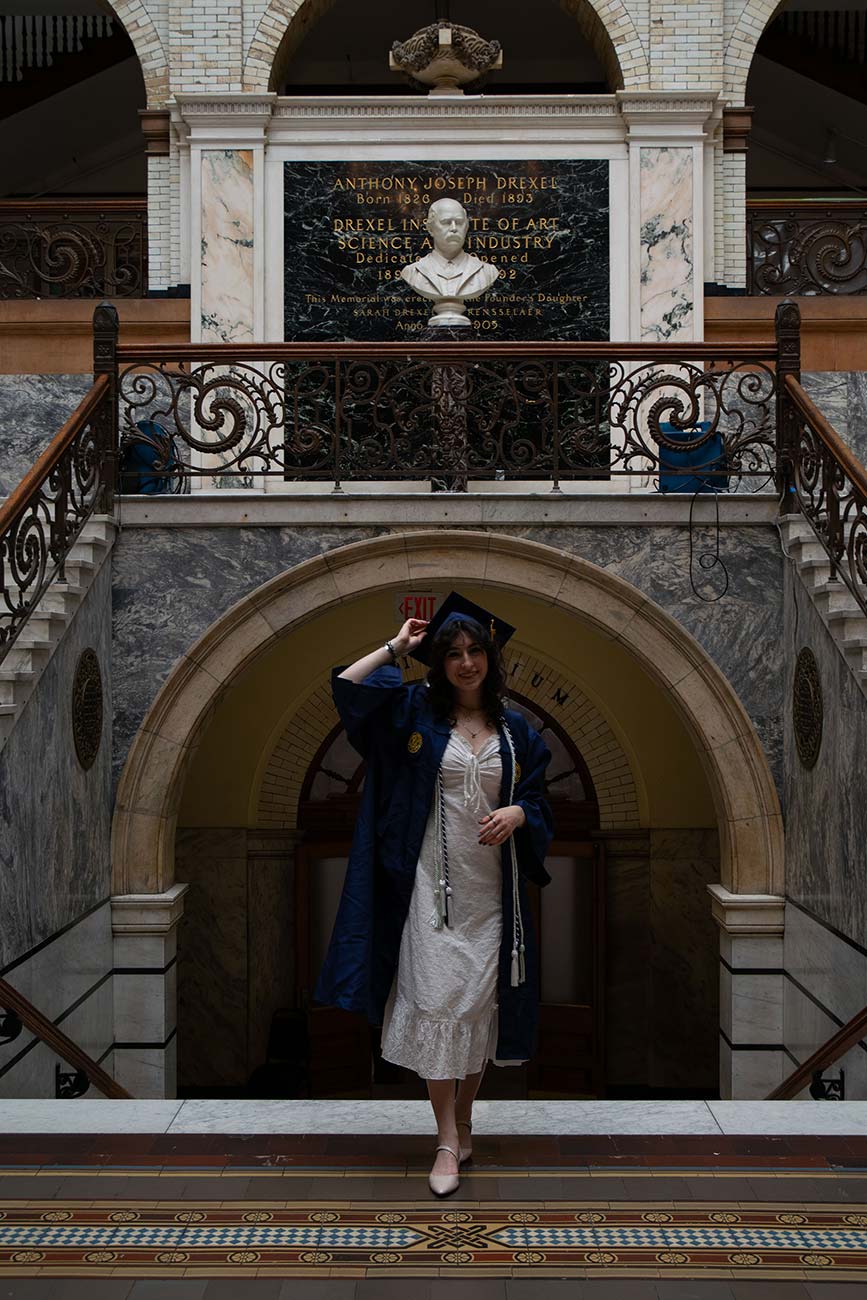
[283,159,610,342]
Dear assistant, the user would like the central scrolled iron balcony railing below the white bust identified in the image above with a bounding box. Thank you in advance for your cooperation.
[110,341,779,491]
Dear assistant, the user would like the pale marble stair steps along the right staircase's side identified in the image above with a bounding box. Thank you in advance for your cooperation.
[780,515,867,694]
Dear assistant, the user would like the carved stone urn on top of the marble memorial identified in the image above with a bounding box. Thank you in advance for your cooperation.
[389,20,503,95]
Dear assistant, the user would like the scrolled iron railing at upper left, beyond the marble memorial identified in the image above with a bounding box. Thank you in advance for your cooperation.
[0,199,147,299]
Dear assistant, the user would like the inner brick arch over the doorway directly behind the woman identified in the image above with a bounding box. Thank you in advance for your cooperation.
[250,640,646,831]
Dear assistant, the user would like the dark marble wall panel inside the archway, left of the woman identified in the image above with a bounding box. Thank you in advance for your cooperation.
[175,828,248,1092]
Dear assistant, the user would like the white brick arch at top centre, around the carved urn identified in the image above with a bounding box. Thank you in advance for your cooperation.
[243,0,649,94]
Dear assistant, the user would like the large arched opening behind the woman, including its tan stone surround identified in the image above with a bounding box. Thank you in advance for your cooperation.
[114,532,783,1095]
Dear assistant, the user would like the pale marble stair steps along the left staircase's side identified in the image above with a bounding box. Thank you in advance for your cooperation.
[0,515,117,749]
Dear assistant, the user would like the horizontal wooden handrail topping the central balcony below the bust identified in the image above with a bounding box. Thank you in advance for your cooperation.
[117,338,777,365]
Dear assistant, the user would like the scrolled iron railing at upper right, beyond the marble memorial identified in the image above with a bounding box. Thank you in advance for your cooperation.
[746,199,867,298]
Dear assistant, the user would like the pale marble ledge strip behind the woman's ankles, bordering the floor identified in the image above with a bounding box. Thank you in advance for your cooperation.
[0,1099,867,1136]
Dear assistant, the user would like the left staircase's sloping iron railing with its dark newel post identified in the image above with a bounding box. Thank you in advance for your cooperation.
[0,307,117,660]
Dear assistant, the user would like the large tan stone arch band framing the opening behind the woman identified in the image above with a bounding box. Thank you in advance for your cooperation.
[112,530,784,894]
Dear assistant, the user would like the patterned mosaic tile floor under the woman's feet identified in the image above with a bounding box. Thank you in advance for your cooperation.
[0,1134,867,1300]
